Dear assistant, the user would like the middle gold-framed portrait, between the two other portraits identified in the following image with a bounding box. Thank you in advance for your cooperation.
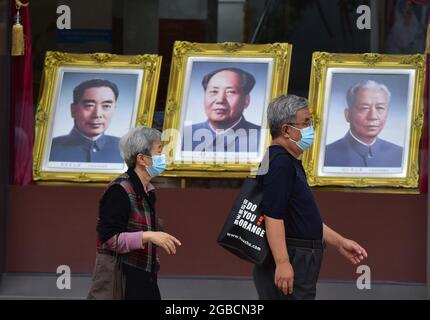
[163,41,292,177]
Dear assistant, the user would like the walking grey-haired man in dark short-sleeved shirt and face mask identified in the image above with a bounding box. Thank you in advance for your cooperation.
[254,95,367,300]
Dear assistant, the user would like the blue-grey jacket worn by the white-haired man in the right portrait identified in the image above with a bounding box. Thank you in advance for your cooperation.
[324,132,403,167]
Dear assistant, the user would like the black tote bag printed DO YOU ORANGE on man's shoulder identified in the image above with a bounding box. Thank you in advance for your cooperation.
[217,155,276,265]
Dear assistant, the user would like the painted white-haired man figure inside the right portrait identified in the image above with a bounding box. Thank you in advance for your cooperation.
[324,80,403,167]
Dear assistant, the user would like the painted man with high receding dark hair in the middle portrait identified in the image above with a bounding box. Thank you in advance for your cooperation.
[182,68,261,152]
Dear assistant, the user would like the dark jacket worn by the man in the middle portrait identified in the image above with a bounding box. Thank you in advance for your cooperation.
[182,117,261,152]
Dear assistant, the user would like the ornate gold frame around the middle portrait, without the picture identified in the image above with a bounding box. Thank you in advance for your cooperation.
[163,41,292,178]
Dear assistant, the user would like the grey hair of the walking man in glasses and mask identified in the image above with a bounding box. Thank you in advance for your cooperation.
[267,94,309,139]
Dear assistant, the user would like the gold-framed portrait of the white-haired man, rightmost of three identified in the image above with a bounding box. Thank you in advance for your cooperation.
[303,52,425,188]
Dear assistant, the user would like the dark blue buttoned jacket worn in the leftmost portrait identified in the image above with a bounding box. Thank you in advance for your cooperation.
[49,128,124,163]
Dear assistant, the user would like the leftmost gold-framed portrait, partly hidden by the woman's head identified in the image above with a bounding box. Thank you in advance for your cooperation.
[33,51,161,182]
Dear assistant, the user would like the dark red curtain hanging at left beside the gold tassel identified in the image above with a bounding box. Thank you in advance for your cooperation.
[9,1,34,185]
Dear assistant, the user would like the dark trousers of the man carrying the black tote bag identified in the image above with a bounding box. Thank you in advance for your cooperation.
[253,240,324,300]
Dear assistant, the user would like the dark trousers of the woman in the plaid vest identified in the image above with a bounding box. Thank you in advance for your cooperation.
[123,264,161,300]
